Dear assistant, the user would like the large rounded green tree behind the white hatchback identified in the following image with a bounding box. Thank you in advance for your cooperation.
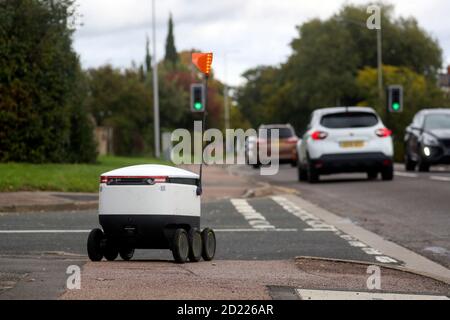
[238,4,442,132]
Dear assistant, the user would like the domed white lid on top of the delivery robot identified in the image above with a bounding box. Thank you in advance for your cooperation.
[101,164,199,179]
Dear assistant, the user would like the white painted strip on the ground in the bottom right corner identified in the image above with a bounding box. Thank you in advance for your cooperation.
[296,289,449,301]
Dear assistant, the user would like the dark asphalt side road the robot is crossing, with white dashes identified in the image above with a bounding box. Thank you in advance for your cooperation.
[0,197,400,299]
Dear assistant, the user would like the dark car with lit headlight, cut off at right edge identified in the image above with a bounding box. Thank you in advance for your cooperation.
[405,109,450,172]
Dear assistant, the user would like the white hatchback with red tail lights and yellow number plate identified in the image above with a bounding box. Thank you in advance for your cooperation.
[297,107,394,183]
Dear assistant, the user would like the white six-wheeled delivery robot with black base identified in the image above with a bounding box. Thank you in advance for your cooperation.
[87,165,216,263]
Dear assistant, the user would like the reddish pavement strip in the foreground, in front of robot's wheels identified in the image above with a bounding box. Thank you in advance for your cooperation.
[62,259,450,300]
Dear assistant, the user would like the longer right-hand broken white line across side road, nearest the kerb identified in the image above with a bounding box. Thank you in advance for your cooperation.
[272,196,398,264]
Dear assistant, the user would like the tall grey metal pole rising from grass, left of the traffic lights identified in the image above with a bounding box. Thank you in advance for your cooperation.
[152,0,161,158]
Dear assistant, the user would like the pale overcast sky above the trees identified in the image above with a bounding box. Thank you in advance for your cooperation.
[75,0,450,85]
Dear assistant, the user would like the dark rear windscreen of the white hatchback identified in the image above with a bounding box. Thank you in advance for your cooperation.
[320,112,378,129]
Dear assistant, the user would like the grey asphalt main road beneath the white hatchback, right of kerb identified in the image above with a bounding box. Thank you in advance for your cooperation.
[234,165,450,268]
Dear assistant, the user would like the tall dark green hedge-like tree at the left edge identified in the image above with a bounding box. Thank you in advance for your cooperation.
[0,0,95,163]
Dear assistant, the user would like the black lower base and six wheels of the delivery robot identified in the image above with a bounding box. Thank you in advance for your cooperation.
[87,215,216,263]
